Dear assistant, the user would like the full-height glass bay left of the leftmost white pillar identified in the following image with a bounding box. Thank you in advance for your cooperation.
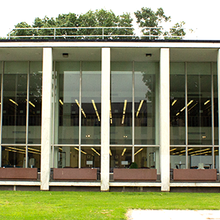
[1,62,42,170]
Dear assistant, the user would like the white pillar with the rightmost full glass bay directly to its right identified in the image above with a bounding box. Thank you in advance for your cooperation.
[160,48,170,191]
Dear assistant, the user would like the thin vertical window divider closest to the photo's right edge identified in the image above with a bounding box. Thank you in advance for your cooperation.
[210,62,215,169]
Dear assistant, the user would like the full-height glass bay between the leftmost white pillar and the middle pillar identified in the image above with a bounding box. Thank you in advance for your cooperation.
[53,62,101,168]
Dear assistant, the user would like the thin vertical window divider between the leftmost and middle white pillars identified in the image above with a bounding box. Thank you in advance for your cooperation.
[78,61,82,168]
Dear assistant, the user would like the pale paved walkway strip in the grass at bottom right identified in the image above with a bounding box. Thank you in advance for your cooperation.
[127,210,220,220]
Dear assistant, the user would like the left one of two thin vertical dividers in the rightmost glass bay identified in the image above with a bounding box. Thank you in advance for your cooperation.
[185,62,188,169]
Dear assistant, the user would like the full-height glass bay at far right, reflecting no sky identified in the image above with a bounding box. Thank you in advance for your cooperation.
[170,63,218,172]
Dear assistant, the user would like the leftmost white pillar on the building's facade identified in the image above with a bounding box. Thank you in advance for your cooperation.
[41,48,53,190]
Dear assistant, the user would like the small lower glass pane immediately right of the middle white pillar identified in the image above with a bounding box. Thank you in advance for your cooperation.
[109,147,132,169]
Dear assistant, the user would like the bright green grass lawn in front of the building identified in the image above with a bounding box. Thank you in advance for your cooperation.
[0,191,220,220]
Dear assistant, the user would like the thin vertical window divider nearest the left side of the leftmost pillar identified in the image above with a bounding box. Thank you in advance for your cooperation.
[25,61,30,168]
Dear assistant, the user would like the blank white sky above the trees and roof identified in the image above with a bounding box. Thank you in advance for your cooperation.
[0,0,220,40]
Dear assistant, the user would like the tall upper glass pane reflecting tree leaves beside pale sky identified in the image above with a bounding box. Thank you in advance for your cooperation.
[134,63,159,144]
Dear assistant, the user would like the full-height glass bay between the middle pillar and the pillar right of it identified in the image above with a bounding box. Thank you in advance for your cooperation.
[110,62,159,171]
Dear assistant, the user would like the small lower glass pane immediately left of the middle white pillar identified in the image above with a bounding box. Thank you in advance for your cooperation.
[81,146,101,168]
